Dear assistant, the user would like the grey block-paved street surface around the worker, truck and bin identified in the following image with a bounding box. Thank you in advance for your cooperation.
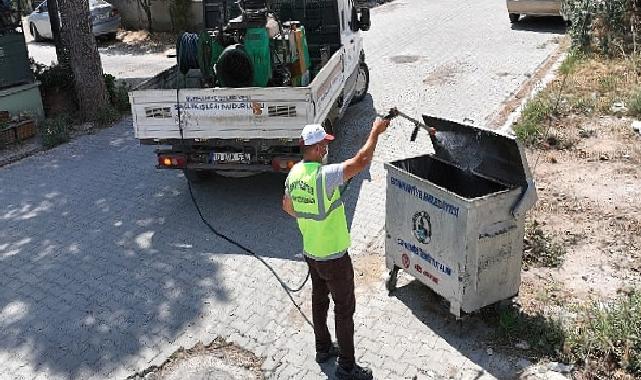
[0,0,560,379]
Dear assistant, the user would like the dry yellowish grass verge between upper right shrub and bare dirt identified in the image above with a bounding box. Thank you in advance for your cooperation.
[514,54,641,149]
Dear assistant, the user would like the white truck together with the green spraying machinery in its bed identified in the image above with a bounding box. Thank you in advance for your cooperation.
[129,0,370,180]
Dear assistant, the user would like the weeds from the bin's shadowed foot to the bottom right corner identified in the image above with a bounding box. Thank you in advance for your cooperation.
[489,290,641,379]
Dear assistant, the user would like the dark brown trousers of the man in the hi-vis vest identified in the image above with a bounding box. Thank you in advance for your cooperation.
[305,253,356,368]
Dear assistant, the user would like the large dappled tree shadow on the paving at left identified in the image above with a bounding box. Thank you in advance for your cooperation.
[0,123,235,378]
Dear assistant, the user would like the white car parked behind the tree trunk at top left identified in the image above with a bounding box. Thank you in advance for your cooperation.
[27,0,120,41]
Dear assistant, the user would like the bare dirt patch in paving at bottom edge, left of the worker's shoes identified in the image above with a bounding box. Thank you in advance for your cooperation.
[127,338,265,380]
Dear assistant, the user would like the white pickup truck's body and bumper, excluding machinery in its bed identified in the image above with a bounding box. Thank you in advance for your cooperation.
[129,0,369,179]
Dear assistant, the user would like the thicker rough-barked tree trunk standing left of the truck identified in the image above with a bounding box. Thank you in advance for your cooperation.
[58,0,109,121]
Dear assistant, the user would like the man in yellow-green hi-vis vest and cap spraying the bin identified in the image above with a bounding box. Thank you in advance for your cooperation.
[283,118,389,380]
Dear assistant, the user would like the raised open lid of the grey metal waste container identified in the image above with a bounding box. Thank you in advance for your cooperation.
[423,115,536,214]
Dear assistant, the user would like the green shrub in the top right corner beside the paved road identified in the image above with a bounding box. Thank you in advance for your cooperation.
[563,0,639,56]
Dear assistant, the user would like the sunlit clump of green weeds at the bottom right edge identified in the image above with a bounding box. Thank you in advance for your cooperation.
[566,291,641,375]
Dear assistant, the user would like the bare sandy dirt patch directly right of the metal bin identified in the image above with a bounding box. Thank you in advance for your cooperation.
[520,117,641,312]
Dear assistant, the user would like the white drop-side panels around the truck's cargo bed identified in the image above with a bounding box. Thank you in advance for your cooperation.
[129,47,354,140]
